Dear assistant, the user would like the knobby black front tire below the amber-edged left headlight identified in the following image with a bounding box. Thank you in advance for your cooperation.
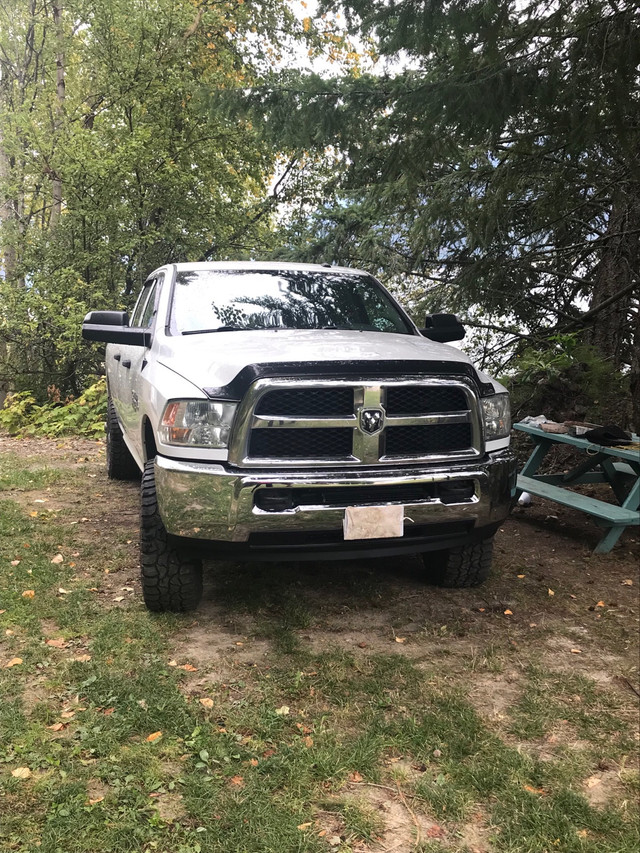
[140,460,202,613]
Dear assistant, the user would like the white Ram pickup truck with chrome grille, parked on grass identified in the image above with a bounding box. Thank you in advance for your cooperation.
[82,262,515,611]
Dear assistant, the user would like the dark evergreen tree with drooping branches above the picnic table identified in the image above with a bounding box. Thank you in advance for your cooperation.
[232,0,640,420]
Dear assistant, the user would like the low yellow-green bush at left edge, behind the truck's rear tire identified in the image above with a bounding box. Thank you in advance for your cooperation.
[0,378,107,438]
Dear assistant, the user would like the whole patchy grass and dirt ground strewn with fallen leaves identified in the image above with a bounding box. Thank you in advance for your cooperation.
[0,442,640,853]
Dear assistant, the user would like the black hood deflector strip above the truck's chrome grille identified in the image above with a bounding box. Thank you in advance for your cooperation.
[202,360,495,402]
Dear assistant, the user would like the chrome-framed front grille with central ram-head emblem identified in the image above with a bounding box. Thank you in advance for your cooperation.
[229,378,482,468]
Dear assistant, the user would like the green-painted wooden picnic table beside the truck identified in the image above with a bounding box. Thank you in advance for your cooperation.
[513,424,640,554]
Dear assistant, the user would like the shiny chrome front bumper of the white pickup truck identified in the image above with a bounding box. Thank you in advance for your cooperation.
[155,451,516,550]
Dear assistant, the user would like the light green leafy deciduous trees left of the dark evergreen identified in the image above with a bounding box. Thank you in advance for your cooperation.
[0,0,291,403]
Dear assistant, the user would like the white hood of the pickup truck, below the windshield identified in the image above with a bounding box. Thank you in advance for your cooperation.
[157,329,480,396]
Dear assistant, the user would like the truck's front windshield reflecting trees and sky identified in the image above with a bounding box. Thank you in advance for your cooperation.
[171,270,414,335]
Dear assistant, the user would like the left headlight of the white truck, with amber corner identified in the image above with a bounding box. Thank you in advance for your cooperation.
[159,400,238,448]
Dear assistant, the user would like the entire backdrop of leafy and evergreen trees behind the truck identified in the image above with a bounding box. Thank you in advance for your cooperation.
[0,0,640,425]
